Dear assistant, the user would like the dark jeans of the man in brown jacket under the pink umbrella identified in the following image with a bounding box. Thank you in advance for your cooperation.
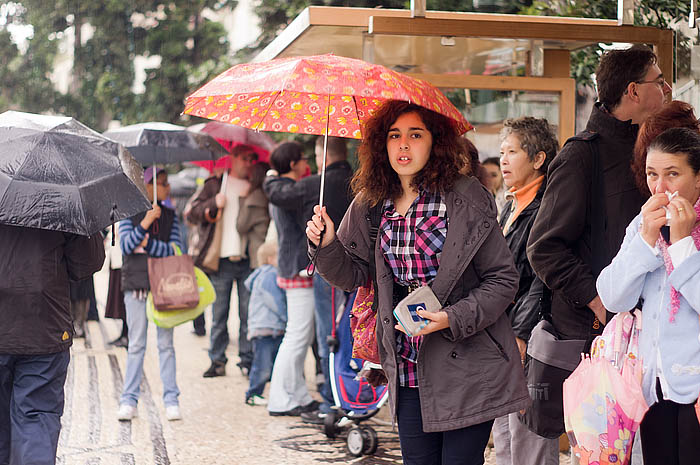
[209,258,253,368]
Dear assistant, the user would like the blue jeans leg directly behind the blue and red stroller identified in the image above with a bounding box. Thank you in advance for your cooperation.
[314,273,345,413]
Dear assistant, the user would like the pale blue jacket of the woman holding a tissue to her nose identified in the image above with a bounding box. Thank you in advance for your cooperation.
[597,215,700,405]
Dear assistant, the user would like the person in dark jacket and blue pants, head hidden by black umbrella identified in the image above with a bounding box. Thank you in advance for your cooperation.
[0,224,105,465]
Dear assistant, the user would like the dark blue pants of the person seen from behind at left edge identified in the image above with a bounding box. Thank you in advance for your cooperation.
[0,350,70,465]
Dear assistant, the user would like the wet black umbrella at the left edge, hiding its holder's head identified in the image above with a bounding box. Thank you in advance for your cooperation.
[0,111,150,236]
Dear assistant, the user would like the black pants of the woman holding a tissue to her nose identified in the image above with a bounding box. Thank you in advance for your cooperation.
[640,381,700,465]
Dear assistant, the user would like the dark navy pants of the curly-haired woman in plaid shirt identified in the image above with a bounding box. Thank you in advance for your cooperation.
[397,387,493,465]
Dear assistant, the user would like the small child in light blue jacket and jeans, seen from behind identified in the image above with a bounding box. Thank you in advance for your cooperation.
[245,242,287,405]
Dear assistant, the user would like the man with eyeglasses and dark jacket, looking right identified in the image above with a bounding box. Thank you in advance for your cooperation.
[525,45,671,456]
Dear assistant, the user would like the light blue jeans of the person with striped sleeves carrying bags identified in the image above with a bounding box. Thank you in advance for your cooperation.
[119,291,180,407]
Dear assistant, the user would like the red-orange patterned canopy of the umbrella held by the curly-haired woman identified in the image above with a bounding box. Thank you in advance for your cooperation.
[183,54,472,139]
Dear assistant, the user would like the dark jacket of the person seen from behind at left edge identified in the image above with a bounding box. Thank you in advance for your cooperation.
[0,225,105,355]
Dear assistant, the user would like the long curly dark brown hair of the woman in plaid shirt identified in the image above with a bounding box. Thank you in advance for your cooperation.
[350,100,465,206]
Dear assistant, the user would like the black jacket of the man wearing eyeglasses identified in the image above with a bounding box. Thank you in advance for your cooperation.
[527,103,644,342]
